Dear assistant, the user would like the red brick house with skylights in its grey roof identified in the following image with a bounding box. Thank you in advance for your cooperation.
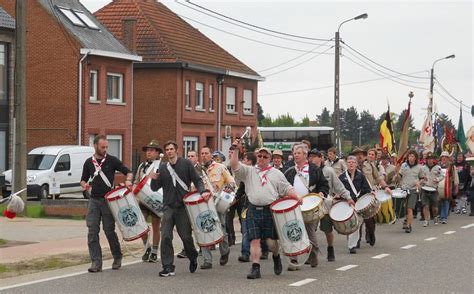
[0,0,141,165]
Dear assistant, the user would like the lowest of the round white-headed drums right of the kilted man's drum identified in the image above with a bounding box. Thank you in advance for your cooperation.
[329,201,359,235]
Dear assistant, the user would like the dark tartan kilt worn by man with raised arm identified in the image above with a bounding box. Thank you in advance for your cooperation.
[245,204,278,241]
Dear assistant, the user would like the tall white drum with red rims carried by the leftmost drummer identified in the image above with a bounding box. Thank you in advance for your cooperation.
[105,187,150,241]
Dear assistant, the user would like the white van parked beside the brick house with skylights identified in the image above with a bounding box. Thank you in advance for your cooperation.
[3,145,94,200]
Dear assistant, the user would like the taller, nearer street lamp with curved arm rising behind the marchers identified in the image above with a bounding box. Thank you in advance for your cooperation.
[334,13,368,152]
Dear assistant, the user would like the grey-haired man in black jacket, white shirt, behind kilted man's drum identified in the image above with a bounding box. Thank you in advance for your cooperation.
[285,144,329,271]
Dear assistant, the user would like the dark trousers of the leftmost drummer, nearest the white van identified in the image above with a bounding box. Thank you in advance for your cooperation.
[86,198,122,267]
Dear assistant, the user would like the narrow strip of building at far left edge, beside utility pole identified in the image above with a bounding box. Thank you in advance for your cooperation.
[0,7,15,173]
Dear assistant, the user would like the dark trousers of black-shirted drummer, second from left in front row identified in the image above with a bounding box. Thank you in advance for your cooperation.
[161,206,198,270]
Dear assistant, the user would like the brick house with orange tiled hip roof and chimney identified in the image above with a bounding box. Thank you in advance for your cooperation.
[94,0,263,161]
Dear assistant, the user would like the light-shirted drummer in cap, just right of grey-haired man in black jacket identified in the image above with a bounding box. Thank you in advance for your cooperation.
[309,148,355,261]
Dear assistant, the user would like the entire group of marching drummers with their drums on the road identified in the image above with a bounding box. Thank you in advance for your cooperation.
[81,136,474,279]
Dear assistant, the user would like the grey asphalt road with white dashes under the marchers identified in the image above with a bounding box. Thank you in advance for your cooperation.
[0,215,474,293]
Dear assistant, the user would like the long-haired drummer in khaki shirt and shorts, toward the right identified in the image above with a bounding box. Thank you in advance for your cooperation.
[394,150,423,233]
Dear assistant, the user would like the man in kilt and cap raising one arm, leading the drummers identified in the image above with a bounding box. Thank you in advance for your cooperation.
[230,139,299,279]
